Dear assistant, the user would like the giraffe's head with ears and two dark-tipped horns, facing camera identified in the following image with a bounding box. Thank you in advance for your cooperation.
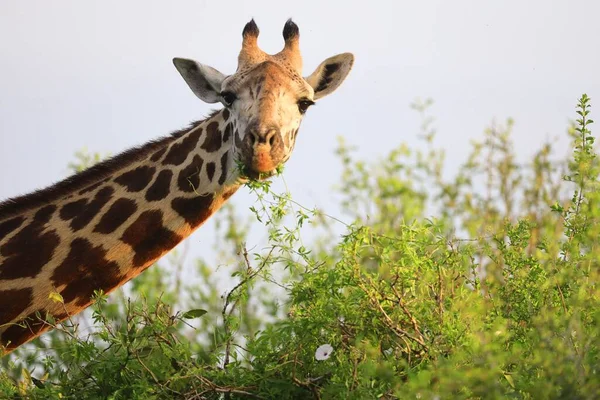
[173,19,354,178]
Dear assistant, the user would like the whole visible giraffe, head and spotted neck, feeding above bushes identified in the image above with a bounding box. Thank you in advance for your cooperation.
[0,19,354,355]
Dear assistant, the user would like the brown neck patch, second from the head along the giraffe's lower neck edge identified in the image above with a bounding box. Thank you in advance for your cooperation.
[121,210,183,267]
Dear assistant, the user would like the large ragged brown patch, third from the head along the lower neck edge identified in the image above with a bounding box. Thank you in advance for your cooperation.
[52,238,122,306]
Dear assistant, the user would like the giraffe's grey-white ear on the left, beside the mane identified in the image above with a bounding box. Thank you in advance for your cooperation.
[173,58,225,103]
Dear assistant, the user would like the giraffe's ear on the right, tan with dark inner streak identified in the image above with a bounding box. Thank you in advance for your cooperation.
[304,53,354,100]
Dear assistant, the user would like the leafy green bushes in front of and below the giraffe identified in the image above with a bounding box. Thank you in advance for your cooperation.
[0,95,600,400]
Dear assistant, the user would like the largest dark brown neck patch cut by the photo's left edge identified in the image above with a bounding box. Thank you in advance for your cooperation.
[0,204,60,279]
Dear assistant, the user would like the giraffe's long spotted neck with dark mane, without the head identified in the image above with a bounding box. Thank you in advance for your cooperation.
[0,109,240,354]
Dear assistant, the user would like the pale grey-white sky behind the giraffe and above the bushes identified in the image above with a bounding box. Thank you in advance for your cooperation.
[0,0,600,266]
